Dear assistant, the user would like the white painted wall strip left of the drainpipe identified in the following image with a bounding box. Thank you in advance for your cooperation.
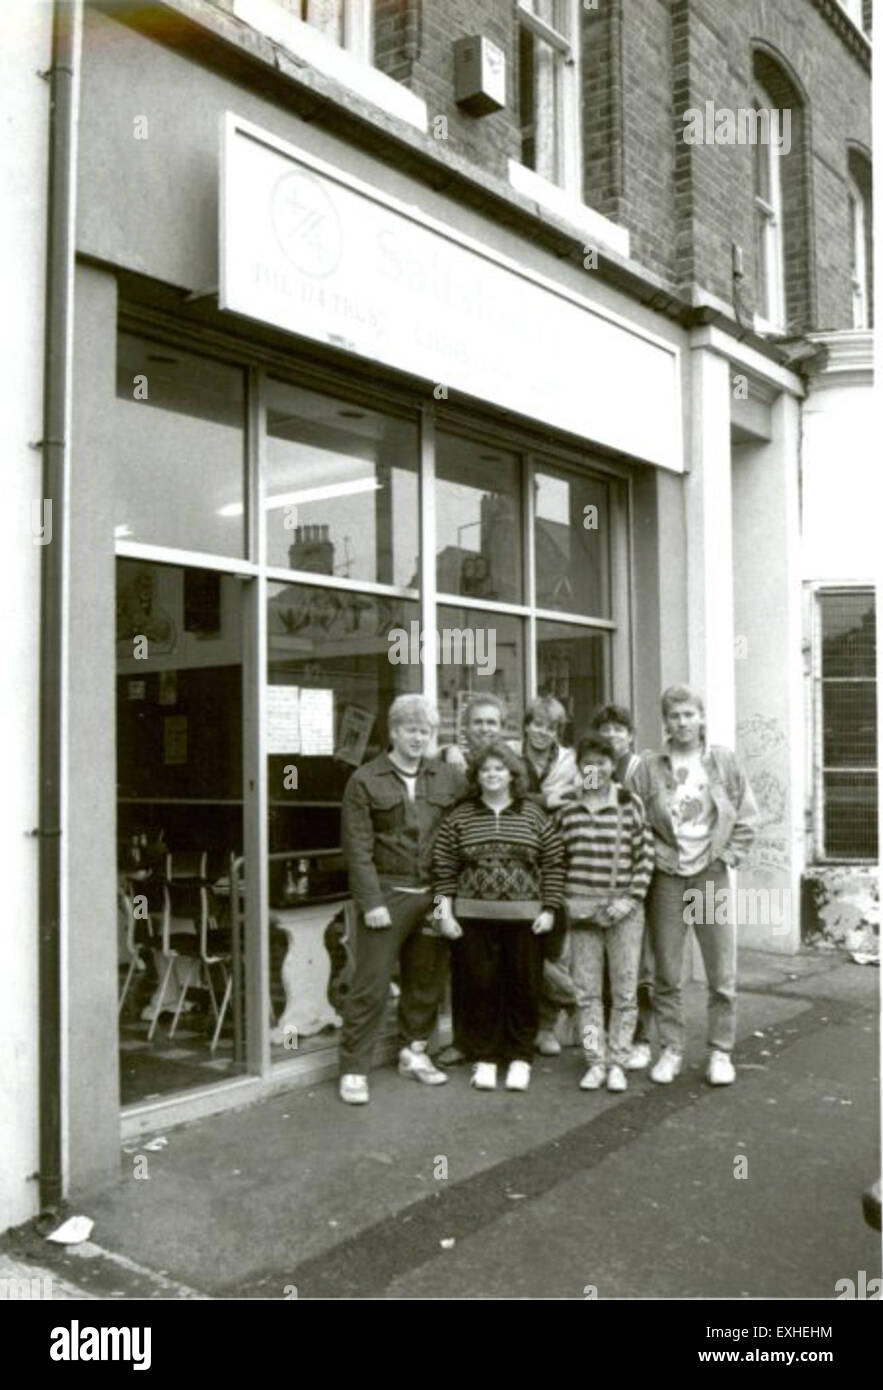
[0,0,51,1230]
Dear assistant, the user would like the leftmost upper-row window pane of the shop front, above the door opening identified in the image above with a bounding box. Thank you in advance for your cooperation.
[113,334,245,556]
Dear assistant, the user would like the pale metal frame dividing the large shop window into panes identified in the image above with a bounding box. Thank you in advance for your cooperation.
[114,312,634,1106]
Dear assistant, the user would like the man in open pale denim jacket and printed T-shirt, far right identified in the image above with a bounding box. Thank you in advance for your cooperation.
[631,685,756,1086]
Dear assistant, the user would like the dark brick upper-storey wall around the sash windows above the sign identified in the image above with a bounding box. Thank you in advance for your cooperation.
[321,0,870,332]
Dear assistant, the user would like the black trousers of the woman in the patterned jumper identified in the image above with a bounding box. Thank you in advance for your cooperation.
[457,922,542,1062]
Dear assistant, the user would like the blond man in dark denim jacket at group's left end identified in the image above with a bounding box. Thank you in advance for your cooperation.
[339,695,466,1105]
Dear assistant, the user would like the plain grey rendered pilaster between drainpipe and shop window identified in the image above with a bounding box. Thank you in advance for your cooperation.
[67,265,120,1191]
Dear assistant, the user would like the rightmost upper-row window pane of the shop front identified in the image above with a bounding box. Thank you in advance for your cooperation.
[534,470,610,617]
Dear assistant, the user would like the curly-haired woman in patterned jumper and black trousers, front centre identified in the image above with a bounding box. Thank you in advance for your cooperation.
[432,742,565,1091]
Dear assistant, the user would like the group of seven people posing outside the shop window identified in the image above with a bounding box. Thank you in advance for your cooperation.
[339,685,756,1104]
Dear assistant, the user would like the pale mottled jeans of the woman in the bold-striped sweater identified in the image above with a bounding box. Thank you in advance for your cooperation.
[570,902,644,1066]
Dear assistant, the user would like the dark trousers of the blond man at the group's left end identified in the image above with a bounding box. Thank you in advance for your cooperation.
[339,890,448,1076]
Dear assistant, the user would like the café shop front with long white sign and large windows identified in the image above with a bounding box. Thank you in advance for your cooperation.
[68,5,684,1182]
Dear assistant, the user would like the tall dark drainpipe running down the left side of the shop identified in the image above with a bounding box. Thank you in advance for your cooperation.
[38,0,82,1212]
